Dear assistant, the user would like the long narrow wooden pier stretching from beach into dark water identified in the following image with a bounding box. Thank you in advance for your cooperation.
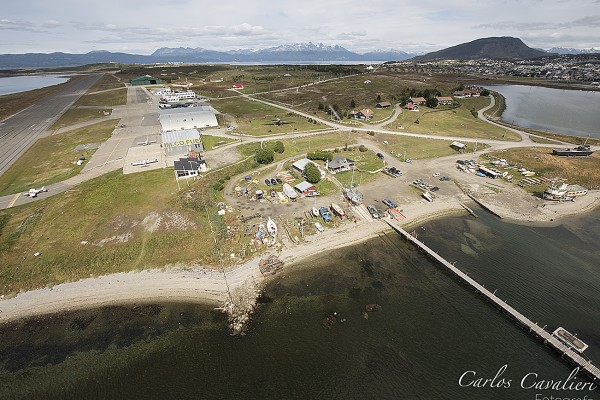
[384,218,600,383]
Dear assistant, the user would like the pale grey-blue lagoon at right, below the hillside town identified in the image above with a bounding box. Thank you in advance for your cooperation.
[489,85,600,138]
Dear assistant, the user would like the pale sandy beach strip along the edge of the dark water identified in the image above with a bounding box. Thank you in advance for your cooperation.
[0,191,600,323]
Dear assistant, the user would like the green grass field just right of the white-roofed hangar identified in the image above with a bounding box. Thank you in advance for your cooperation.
[211,97,326,136]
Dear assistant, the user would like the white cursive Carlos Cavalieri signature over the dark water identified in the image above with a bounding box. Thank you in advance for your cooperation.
[458,364,598,392]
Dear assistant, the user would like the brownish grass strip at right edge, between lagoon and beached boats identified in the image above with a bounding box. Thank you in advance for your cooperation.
[490,148,600,190]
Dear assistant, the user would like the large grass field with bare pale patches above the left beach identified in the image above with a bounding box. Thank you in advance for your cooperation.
[0,155,256,294]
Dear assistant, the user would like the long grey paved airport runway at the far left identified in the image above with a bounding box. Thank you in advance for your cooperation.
[0,74,102,175]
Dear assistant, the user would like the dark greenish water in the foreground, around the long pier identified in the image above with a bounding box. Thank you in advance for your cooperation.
[0,210,600,399]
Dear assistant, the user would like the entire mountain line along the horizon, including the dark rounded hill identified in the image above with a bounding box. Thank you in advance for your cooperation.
[0,37,600,69]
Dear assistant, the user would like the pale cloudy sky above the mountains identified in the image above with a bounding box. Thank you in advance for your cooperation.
[0,0,600,54]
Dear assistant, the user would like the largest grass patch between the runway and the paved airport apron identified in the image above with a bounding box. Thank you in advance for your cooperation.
[0,120,118,195]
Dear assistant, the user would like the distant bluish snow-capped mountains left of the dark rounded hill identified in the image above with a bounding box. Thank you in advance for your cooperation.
[0,42,415,69]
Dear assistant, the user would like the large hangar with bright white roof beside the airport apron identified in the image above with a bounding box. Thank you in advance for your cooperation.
[158,106,219,132]
